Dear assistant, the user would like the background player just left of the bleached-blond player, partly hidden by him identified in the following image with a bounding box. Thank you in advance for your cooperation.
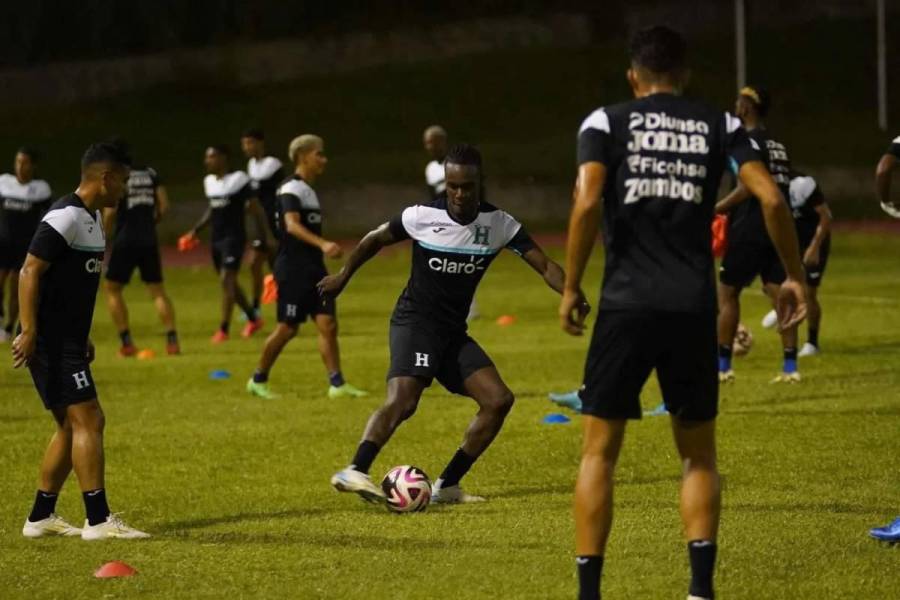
[241,128,284,316]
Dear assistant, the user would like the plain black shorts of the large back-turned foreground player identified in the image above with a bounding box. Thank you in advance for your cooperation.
[579,310,719,421]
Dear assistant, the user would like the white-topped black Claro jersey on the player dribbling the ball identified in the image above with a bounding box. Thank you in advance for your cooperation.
[390,198,534,331]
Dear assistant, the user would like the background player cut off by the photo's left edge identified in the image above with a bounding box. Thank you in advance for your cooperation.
[0,147,52,342]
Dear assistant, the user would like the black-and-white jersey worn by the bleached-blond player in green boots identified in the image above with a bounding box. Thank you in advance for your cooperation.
[275,175,325,276]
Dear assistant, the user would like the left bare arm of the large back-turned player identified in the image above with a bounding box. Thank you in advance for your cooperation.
[559,162,606,335]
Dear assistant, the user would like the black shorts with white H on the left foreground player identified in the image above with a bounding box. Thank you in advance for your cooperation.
[28,342,97,410]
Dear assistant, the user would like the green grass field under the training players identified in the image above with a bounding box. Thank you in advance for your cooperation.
[0,234,900,600]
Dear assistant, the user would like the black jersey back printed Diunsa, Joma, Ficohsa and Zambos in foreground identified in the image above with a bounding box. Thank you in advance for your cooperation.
[578,94,759,312]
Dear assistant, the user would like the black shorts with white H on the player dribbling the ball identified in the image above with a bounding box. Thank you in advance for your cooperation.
[387,323,494,396]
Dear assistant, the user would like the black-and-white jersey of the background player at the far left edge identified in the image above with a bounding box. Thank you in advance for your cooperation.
[0,173,51,245]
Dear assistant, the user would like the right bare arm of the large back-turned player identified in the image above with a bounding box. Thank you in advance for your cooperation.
[739,160,806,329]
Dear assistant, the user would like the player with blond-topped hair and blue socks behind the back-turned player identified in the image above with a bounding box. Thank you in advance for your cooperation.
[716,86,800,383]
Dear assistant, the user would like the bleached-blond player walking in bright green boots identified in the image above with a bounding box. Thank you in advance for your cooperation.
[247,134,367,399]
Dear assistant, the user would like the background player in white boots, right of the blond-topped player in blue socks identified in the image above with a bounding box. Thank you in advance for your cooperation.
[762,171,832,357]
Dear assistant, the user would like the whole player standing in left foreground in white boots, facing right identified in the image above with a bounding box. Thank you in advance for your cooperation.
[12,143,150,540]
